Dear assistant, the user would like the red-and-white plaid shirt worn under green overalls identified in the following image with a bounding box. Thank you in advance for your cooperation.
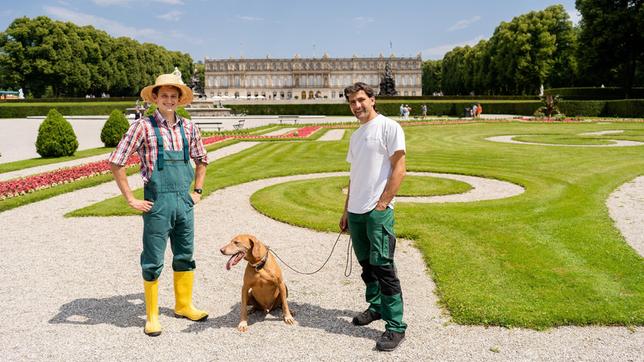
[108,110,208,183]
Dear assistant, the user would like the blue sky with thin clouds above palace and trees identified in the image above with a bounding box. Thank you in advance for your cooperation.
[0,0,579,61]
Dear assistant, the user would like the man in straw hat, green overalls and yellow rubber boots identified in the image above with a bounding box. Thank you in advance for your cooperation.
[109,68,208,336]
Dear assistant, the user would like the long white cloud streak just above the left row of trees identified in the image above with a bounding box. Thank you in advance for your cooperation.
[44,6,160,38]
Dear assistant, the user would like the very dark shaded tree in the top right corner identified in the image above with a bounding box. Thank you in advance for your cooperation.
[575,0,644,97]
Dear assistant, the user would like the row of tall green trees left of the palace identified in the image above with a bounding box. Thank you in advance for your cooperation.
[0,16,193,97]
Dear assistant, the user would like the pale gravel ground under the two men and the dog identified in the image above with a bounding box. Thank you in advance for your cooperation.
[0,143,644,361]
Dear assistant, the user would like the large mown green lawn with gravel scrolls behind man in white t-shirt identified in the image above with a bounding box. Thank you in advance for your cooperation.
[61,123,644,328]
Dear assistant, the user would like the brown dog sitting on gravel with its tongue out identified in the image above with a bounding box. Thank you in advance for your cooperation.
[220,234,295,332]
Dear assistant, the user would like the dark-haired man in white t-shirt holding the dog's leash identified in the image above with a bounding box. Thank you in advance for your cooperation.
[340,82,407,351]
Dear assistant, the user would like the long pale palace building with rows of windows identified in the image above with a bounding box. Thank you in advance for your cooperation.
[204,54,422,100]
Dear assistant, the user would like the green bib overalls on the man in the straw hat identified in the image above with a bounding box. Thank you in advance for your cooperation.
[141,116,195,281]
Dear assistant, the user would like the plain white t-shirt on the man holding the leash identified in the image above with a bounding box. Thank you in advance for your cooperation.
[347,114,405,214]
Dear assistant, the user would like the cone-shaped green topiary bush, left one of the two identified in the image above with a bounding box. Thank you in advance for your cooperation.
[36,108,78,157]
